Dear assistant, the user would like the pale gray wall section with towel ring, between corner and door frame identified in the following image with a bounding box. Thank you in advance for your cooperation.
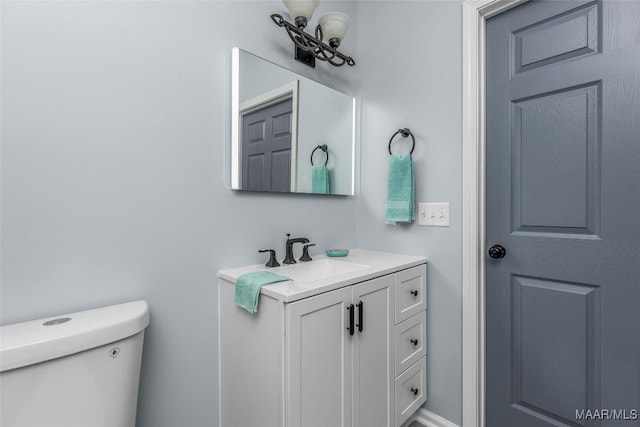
[356,0,462,424]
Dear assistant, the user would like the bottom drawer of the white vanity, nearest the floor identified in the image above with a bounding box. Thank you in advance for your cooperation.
[396,357,427,427]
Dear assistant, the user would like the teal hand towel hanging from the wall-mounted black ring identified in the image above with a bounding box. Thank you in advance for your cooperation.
[385,154,416,222]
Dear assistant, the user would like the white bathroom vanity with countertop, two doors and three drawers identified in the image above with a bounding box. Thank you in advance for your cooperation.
[218,250,427,427]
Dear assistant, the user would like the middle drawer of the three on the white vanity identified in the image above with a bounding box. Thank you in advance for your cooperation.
[395,311,427,375]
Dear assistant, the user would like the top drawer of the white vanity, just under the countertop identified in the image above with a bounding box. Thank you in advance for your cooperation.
[395,264,427,324]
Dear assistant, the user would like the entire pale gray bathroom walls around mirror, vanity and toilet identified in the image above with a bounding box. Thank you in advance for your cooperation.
[0,0,461,427]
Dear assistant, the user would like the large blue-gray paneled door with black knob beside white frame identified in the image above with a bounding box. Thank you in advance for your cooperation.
[486,0,640,427]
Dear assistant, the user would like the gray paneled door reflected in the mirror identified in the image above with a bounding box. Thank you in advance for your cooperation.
[242,98,293,192]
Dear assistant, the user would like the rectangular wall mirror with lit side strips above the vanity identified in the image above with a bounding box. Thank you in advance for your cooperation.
[225,48,356,195]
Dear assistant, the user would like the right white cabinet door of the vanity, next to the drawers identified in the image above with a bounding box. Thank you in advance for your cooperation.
[353,275,395,427]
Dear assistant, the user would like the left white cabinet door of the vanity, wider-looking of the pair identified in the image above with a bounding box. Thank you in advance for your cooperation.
[286,287,357,427]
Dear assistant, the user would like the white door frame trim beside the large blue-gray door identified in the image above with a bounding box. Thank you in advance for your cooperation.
[462,0,529,427]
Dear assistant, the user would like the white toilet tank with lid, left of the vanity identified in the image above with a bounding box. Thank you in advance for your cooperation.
[0,301,149,427]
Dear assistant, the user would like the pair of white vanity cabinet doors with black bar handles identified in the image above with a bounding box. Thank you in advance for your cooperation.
[286,275,394,426]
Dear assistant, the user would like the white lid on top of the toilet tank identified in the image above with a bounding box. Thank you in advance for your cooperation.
[0,301,149,372]
